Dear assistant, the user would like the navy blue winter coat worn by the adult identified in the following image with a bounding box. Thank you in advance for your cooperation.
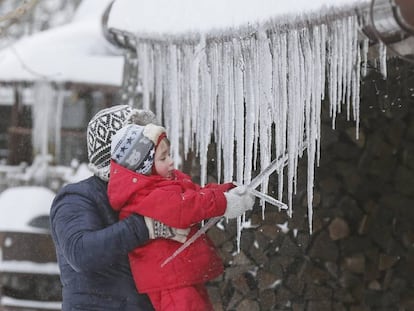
[50,176,153,311]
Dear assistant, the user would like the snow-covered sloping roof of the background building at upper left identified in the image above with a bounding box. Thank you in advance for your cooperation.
[0,0,123,86]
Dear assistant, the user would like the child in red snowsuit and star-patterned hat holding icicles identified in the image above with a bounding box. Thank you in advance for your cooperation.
[108,124,254,311]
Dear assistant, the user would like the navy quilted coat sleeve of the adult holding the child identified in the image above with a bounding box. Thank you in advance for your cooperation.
[50,183,148,271]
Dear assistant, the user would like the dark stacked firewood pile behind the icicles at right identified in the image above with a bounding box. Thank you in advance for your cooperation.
[204,60,414,311]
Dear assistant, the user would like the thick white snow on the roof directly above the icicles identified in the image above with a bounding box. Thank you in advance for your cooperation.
[108,0,368,34]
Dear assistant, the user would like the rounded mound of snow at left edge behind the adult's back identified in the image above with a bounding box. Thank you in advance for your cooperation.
[0,186,55,233]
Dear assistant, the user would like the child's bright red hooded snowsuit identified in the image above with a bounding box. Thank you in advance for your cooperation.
[108,161,234,311]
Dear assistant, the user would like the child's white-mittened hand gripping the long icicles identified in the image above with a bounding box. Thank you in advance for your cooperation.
[223,186,254,219]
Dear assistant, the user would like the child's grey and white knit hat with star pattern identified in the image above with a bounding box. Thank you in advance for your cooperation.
[111,124,165,174]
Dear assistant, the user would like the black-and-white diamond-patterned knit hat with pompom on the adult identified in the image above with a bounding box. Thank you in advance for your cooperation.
[86,105,157,181]
